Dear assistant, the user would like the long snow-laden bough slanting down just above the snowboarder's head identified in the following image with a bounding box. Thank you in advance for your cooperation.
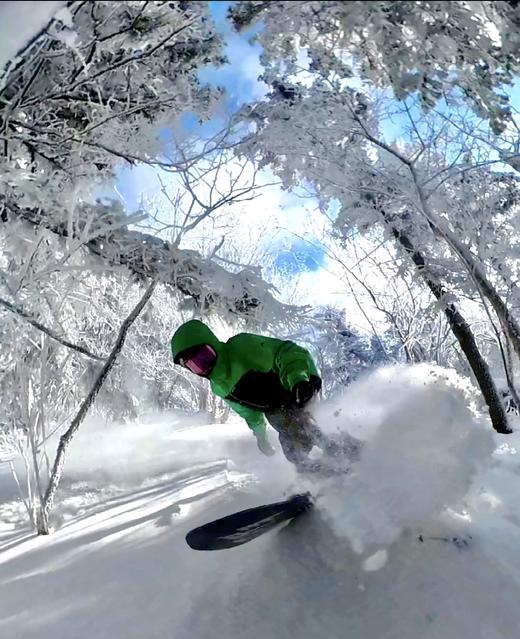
[5,200,286,319]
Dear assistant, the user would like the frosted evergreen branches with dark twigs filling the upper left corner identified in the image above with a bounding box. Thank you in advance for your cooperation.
[0,1,228,214]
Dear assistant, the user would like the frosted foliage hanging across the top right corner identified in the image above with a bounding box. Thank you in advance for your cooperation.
[234,0,520,133]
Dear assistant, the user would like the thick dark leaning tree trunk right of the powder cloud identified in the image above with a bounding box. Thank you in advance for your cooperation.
[392,224,513,435]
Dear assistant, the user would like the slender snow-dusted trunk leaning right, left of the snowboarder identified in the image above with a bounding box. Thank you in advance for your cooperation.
[37,280,157,535]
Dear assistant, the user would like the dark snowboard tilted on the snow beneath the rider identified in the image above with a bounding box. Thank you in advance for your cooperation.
[186,493,313,550]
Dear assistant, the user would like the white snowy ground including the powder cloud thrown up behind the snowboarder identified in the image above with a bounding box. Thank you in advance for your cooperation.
[0,366,520,639]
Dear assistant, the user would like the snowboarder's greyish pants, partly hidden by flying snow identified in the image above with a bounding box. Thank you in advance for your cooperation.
[265,405,326,466]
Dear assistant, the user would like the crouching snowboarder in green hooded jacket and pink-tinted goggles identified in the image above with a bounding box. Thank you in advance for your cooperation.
[171,320,327,469]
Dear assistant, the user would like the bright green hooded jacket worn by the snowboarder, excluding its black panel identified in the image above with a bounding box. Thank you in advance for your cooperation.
[171,320,319,435]
